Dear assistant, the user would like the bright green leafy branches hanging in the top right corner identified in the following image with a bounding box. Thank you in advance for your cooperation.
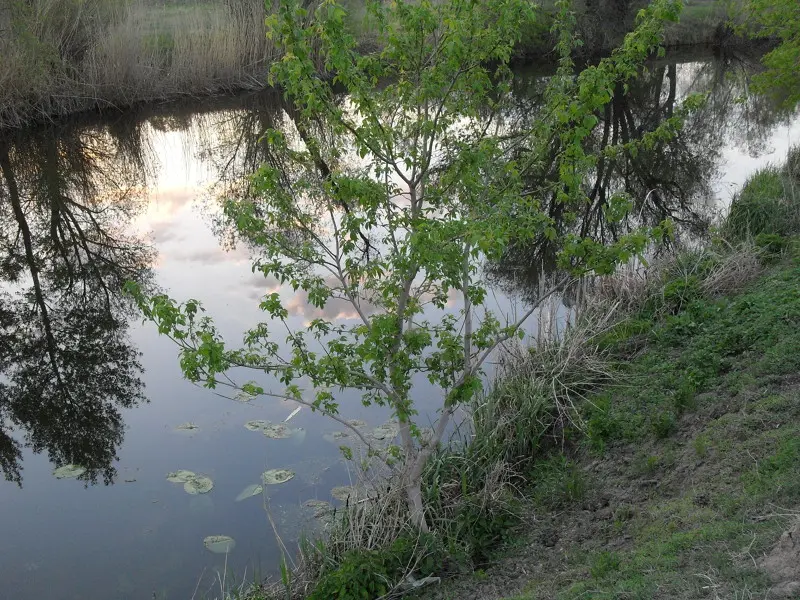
[746,0,800,106]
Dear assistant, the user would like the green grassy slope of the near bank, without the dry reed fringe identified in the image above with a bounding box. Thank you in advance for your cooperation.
[418,150,800,600]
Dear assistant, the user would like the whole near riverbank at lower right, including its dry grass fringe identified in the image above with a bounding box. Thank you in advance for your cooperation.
[239,150,800,600]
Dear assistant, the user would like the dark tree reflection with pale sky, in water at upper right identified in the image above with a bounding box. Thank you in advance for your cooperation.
[490,50,789,293]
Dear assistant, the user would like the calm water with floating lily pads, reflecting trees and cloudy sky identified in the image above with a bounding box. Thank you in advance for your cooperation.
[0,49,800,600]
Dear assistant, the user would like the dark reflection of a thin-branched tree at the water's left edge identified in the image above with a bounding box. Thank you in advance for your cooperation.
[0,127,154,483]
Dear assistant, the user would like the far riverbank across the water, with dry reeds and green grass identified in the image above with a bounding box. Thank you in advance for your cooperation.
[0,0,751,130]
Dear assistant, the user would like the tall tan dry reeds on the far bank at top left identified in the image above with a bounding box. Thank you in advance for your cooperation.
[0,0,273,128]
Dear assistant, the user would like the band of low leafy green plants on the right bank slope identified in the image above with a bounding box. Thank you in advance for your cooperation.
[587,258,800,449]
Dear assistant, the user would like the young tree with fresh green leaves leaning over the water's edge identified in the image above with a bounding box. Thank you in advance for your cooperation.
[134,0,680,529]
